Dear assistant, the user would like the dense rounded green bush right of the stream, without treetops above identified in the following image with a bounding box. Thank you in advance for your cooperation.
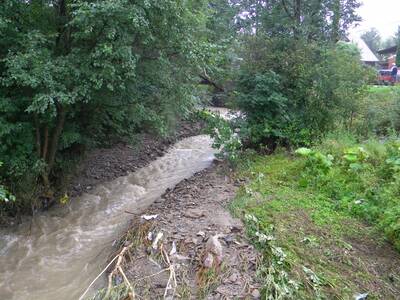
[237,37,370,147]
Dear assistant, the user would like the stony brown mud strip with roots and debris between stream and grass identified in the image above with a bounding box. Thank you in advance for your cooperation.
[111,163,260,299]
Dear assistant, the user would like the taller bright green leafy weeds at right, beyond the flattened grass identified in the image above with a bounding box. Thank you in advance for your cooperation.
[296,140,400,250]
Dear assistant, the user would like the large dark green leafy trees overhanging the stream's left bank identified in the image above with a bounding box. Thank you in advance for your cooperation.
[0,0,217,216]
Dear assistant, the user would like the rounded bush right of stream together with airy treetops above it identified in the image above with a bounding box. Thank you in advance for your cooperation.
[234,0,371,151]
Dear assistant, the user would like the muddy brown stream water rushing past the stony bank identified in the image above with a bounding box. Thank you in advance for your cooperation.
[0,135,214,300]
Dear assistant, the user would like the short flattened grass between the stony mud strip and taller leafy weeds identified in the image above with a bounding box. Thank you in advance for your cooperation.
[230,148,400,299]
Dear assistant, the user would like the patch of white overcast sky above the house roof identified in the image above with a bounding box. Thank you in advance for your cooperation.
[351,0,400,38]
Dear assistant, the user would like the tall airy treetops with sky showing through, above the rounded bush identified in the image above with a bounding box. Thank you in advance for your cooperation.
[232,0,361,42]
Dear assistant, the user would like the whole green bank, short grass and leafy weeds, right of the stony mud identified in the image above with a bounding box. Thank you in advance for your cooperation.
[231,139,400,299]
